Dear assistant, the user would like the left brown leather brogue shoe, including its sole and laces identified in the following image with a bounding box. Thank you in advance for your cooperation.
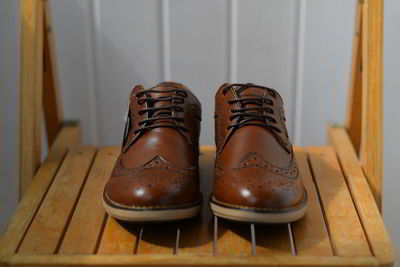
[103,82,201,221]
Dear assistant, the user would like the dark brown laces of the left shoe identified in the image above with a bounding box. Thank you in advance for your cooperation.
[123,89,189,151]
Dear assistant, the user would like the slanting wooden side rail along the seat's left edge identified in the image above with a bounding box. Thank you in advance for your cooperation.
[0,124,80,264]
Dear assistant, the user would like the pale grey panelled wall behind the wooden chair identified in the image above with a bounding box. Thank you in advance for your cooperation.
[0,0,400,262]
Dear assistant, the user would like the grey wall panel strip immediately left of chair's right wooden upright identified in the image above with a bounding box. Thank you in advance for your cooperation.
[299,0,356,145]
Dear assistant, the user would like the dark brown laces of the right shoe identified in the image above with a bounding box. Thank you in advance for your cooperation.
[222,83,282,133]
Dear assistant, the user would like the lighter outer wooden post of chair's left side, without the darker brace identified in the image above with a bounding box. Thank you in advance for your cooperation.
[19,0,43,198]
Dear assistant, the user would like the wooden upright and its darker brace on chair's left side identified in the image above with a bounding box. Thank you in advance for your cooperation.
[19,0,80,198]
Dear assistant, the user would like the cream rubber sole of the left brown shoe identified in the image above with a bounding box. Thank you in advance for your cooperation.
[103,197,201,222]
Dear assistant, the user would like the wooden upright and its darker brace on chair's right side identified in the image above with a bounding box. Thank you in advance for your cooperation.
[346,0,383,213]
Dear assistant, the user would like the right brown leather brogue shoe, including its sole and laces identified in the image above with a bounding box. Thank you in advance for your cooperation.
[210,83,307,223]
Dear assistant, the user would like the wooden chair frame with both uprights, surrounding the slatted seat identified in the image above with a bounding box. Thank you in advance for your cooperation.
[0,0,394,267]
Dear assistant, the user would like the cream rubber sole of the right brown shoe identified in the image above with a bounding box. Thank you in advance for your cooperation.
[209,192,308,223]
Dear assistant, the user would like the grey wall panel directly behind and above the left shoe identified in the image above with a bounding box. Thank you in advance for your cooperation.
[95,0,162,147]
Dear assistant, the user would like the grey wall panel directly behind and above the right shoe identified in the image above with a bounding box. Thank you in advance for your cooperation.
[237,0,297,138]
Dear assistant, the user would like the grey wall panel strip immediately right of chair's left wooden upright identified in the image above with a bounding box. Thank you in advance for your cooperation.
[50,0,96,146]
